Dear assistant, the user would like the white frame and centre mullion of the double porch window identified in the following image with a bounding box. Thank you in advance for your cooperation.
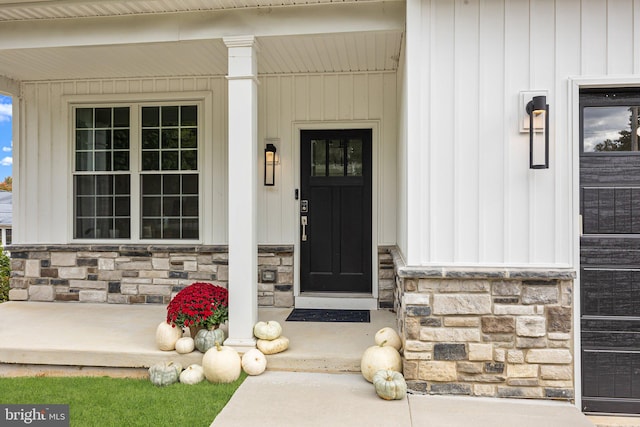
[64,92,212,245]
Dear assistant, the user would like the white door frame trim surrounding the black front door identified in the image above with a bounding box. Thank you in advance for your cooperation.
[291,120,381,310]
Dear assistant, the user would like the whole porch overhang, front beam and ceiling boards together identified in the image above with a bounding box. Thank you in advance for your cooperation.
[0,0,404,82]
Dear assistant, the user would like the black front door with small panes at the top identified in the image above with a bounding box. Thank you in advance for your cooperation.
[300,129,372,293]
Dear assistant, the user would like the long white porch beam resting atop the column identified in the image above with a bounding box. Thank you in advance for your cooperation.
[0,1,404,50]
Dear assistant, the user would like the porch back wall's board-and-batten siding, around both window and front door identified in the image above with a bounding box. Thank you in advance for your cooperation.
[14,72,397,244]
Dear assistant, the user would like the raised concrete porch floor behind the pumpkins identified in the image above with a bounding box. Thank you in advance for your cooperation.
[0,302,640,427]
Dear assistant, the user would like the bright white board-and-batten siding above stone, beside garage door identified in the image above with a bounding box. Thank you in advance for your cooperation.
[398,0,640,267]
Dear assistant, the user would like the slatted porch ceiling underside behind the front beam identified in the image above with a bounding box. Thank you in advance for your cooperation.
[0,31,402,81]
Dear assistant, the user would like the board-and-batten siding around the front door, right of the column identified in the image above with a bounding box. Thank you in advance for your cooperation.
[258,72,397,246]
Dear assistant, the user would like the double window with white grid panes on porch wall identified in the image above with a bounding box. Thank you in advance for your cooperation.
[74,105,199,240]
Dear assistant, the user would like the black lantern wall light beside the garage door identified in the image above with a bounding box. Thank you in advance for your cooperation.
[526,96,549,169]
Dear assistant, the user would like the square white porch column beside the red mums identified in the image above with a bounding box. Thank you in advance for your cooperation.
[223,36,258,352]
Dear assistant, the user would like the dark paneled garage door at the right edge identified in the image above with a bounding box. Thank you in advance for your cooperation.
[580,89,640,414]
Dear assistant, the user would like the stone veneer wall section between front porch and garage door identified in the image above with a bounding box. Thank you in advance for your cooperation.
[391,251,575,400]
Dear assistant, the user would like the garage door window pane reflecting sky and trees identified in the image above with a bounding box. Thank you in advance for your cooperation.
[583,106,640,153]
